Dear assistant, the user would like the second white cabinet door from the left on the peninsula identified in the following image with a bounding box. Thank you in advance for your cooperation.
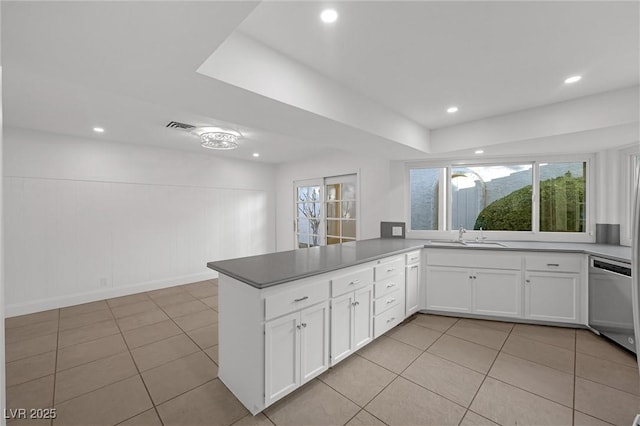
[300,301,329,384]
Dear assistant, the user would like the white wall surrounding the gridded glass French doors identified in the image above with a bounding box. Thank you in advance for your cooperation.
[276,152,390,251]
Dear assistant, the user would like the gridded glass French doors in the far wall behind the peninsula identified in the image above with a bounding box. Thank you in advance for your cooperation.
[294,174,358,248]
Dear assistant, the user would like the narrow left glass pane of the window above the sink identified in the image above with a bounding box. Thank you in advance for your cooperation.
[409,168,442,231]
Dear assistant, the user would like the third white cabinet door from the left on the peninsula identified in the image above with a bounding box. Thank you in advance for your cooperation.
[331,293,354,365]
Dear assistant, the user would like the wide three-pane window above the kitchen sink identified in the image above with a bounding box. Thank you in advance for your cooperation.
[408,161,588,240]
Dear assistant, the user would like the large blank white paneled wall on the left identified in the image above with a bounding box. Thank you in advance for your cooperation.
[4,129,275,316]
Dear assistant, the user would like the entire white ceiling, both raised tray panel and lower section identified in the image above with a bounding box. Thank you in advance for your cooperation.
[1,1,640,163]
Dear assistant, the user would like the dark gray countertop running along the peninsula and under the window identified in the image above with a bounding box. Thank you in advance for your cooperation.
[207,238,631,289]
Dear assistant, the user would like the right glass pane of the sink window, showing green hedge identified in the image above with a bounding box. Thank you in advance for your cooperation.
[540,162,587,232]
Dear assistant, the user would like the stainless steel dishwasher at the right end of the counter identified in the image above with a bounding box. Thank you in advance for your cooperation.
[589,256,636,353]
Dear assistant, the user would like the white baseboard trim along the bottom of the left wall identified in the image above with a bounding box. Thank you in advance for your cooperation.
[5,271,218,318]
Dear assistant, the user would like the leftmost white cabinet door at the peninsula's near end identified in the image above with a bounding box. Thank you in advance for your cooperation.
[265,312,300,405]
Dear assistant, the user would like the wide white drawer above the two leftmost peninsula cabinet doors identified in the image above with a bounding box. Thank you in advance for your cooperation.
[265,281,329,320]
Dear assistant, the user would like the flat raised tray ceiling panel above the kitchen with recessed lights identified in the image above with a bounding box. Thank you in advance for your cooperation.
[239,1,640,129]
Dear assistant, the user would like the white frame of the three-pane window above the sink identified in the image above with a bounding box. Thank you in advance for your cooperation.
[404,154,596,242]
